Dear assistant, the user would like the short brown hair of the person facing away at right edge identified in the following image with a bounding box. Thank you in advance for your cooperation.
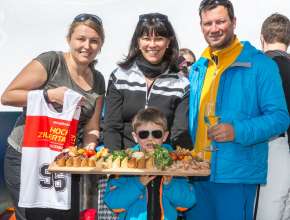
[261,13,290,46]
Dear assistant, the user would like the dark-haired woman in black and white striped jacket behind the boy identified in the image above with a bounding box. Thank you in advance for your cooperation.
[98,13,191,220]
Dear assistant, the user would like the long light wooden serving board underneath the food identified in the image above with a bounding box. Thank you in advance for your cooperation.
[48,163,210,176]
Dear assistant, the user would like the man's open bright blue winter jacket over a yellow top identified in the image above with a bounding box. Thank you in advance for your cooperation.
[189,42,289,184]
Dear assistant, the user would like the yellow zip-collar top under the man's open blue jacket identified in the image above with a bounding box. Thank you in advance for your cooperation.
[195,38,243,159]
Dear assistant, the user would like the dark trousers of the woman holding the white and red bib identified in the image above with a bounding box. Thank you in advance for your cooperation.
[4,145,80,220]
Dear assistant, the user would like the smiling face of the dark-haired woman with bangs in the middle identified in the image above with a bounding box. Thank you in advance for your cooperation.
[138,33,170,64]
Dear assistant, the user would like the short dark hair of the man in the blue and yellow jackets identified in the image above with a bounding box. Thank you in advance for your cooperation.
[199,0,235,21]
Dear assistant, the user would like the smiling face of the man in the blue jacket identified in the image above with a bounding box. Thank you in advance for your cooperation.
[200,6,236,51]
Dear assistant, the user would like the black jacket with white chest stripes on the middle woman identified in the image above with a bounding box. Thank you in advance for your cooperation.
[104,62,191,150]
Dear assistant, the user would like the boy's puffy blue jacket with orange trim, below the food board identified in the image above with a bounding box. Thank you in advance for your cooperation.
[104,145,195,220]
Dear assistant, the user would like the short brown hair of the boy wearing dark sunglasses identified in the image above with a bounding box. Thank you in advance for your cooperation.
[132,107,167,131]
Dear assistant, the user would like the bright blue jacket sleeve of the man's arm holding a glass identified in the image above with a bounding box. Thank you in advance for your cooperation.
[233,55,289,146]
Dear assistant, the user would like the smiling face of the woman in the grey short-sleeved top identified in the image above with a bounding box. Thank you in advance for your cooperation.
[67,24,102,65]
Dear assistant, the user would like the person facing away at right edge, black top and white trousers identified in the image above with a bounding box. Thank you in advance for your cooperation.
[257,13,290,220]
